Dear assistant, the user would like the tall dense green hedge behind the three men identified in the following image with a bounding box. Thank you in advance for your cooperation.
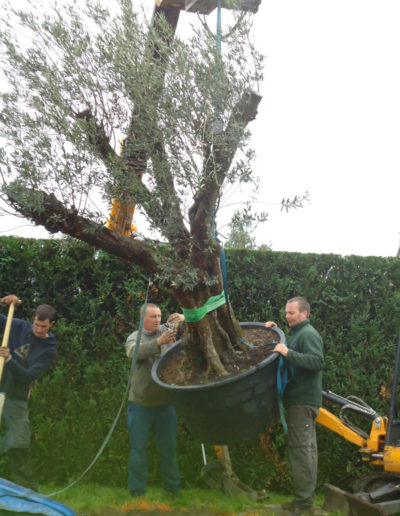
[0,237,400,490]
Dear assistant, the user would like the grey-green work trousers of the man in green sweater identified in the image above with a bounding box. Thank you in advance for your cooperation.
[286,405,319,509]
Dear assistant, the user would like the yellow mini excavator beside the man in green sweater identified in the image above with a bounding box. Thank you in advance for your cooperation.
[316,334,400,516]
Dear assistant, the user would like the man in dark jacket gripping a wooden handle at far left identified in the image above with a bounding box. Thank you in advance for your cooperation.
[0,295,57,490]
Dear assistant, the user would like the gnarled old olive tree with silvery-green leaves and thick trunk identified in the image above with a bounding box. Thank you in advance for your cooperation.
[0,0,262,374]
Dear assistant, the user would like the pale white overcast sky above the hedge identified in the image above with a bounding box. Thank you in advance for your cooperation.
[0,0,400,256]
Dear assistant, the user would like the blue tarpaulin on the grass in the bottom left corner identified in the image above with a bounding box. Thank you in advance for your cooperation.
[0,478,76,516]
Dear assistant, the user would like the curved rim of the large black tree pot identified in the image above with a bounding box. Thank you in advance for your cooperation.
[151,322,286,391]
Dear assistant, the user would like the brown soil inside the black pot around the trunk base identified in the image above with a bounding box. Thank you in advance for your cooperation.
[159,327,280,385]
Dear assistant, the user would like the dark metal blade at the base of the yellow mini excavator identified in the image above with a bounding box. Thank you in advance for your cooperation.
[324,484,400,516]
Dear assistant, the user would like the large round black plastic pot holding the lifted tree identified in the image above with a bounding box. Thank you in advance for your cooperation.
[152,322,285,445]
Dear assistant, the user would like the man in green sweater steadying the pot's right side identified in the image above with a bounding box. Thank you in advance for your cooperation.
[265,297,324,514]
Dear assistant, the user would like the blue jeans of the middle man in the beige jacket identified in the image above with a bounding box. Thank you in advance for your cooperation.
[128,401,181,494]
